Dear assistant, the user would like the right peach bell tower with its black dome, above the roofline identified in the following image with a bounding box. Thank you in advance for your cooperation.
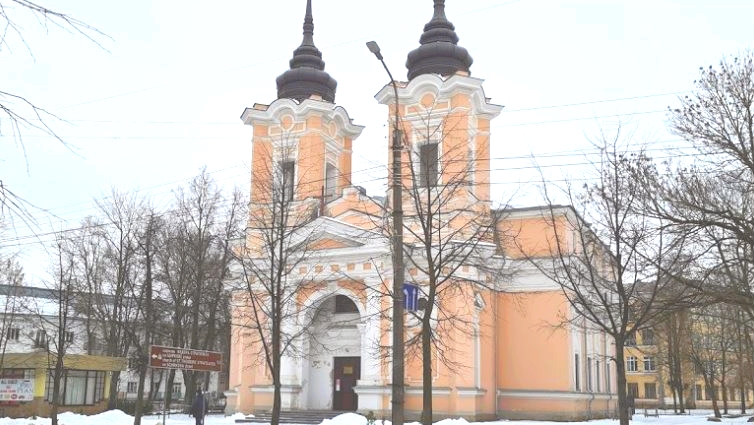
[376,0,502,225]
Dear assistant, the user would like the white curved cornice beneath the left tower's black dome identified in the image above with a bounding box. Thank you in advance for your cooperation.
[241,98,364,138]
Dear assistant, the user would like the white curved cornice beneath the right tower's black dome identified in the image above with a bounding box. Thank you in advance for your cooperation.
[375,74,503,119]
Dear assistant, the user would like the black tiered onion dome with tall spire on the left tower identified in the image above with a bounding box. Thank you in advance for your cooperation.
[275,0,338,102]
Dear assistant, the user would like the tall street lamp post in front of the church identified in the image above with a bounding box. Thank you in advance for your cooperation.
[367,41,405,425]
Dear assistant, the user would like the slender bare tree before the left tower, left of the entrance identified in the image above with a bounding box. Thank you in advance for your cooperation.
[235,141,328,425]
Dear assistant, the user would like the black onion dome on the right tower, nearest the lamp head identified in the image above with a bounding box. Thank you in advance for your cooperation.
[406,0,474,80]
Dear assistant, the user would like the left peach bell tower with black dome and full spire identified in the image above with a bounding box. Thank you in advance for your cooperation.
[241,0,363,207]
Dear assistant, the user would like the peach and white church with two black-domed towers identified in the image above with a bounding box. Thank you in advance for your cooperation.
[226,0,617,421]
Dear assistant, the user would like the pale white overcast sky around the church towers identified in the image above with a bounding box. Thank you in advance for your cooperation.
[0,0,754,280]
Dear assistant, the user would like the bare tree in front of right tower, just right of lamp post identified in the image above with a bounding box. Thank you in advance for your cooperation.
[394,108,505,425]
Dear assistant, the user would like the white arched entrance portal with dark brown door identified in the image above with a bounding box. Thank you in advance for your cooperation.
[304,295,361,410]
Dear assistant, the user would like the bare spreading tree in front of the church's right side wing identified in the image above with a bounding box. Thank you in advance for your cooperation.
[522,130,688,425]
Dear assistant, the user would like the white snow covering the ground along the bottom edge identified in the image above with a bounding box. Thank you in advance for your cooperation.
[0,410,750,425]
